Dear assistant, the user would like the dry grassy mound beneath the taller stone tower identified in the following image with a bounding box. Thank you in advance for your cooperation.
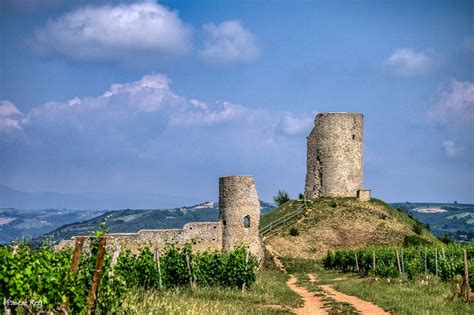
[260,198,439,259]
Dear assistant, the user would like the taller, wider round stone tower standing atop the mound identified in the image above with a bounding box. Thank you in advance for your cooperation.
[305,113,363,198]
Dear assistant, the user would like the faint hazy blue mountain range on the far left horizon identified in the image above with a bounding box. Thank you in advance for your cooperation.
[0,185,202,210]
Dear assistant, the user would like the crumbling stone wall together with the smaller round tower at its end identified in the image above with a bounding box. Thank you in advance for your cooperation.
[57,176,263,260]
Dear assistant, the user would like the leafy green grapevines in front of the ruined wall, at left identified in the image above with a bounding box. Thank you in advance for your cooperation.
[0,242,258,314]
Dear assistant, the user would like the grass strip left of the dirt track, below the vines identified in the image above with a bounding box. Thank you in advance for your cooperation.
[122,271,303,314]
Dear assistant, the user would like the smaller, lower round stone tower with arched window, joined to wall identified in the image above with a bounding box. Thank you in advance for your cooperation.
[219,176,263,259]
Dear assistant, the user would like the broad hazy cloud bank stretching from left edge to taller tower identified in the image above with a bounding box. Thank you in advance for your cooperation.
[0,74,305,198]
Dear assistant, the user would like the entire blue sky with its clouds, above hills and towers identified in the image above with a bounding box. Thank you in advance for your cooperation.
[0,0,474,203]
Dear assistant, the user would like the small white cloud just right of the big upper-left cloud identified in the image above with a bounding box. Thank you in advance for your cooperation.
[200,21,260,63]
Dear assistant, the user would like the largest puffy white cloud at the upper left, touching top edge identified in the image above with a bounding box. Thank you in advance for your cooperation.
[32,2,191,62]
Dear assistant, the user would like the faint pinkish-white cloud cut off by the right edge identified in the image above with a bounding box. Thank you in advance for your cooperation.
[429,79,474,124]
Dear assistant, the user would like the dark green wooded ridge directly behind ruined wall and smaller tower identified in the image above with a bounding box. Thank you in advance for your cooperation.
[36,201,275,242]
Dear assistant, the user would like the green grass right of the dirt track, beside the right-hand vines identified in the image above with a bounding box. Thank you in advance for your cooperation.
[282,258,474,315]
